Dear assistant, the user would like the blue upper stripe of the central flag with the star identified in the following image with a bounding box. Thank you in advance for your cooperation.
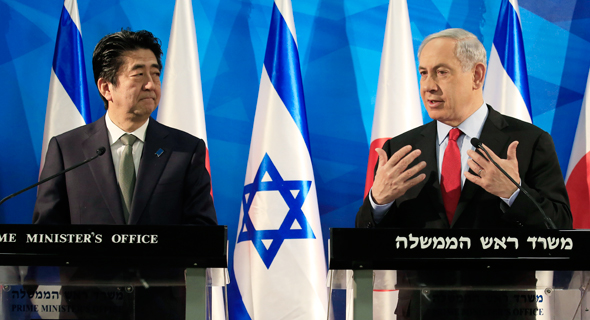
[264,3,311,153]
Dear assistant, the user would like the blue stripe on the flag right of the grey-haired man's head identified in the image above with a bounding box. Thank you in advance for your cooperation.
[494,0,533,119]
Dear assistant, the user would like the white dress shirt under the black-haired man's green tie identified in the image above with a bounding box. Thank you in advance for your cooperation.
[105,111,150,182]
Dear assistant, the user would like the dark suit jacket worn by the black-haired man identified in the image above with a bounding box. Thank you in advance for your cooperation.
[33,117,217,225]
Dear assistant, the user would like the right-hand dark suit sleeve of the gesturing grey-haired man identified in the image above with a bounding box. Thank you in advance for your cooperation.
[503,132,573,229]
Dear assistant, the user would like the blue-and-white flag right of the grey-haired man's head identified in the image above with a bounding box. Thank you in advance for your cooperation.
[484,0,532,123]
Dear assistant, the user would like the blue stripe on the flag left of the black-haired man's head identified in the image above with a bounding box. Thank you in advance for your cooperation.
[53,7,92,123]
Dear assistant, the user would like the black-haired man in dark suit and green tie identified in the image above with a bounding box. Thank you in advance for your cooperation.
[33,30,217,319]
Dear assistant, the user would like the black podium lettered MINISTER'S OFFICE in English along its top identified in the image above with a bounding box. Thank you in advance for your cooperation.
[0,225,229,320]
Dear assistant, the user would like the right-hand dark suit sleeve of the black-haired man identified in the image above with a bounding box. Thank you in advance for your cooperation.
[182,139,217,226]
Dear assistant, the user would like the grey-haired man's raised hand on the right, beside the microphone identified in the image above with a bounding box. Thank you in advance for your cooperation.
[470,141,520,198]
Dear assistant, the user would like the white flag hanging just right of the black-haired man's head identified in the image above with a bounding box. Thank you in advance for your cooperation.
[158,0,213,189]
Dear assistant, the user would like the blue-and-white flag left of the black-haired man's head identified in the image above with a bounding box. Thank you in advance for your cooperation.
[41,0,91,170]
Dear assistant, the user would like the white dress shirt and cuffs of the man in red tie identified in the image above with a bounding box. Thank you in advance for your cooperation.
[369,102,520,223]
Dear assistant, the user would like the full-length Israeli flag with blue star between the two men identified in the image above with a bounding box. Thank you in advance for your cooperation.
[233,0,327,320]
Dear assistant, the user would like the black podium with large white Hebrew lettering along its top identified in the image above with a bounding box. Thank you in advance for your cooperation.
[328,228,590,320]
